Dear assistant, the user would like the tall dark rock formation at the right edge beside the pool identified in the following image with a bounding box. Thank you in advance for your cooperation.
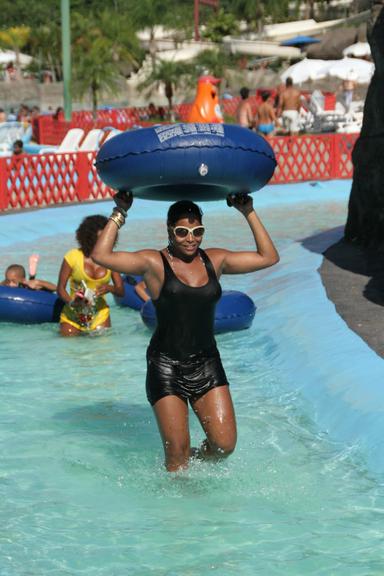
[345,0,384,251]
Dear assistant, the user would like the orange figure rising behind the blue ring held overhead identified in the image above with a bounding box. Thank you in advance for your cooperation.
[187,76,223,123]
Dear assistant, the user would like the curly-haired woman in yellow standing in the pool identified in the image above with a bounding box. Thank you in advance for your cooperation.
[57,215,124,336]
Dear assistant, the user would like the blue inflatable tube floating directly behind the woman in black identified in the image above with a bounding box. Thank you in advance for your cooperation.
[140,290,256,334]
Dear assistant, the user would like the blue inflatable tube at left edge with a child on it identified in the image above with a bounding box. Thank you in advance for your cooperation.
[0,286,64,324]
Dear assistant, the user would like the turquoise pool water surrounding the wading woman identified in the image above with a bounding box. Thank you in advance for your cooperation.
[0,187,384,576]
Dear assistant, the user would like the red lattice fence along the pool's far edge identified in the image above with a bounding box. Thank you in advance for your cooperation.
[0,134,358,211]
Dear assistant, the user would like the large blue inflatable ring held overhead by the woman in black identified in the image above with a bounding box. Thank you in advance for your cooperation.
[96,123,276,201]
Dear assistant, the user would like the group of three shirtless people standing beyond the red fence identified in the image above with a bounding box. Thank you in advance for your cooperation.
[236,78,302,138]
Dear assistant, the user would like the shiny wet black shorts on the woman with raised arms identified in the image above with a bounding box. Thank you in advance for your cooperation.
[146,348,228,406]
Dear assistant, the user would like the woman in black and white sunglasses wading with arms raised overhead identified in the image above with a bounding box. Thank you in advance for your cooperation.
[91,192,279,472]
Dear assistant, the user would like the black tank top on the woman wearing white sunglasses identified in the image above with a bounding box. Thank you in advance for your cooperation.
[149,250,221,360]
